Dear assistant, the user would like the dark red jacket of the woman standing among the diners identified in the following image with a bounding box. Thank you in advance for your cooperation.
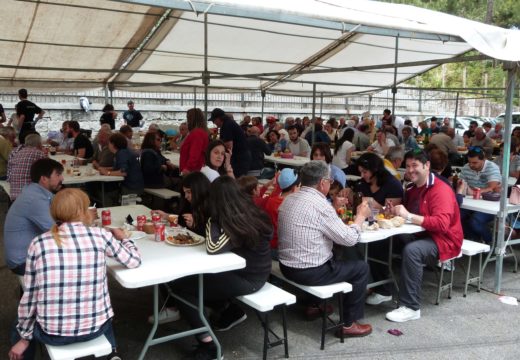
[179,128,209,172]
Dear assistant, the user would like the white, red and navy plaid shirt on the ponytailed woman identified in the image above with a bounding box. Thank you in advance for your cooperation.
[17,222,141,340]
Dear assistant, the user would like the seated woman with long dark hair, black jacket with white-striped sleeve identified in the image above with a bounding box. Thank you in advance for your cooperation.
[172,176,273,359]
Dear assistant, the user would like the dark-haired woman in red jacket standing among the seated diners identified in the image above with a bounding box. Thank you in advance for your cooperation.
[179,108,209,175]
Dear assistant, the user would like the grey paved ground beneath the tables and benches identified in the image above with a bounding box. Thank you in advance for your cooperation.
[0,198,520,360]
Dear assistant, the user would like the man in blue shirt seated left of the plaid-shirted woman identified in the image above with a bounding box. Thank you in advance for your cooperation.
[4,159,63,275]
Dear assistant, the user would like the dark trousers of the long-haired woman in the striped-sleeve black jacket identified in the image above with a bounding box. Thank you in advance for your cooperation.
[169,271,265,339]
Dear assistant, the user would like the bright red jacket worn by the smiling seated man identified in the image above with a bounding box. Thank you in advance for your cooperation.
[404,173,464,261]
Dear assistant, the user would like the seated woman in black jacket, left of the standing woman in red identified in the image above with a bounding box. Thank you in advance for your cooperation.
[141,132,176,189]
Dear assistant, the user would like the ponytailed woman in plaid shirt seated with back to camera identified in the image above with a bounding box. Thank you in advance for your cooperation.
[9,189,141,360]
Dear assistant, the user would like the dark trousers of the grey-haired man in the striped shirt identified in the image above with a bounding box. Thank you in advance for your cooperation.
[280,259,368,326]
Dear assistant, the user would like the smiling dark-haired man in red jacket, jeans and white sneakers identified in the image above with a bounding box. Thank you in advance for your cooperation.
[386,150,463,322]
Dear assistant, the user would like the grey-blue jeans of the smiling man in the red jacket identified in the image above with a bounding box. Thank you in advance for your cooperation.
[399,238,439,310]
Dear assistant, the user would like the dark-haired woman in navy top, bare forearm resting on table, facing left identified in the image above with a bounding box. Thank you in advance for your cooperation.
[99,133,144,200]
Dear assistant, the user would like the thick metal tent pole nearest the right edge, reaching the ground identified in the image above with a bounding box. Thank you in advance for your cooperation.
[495,63,518,293]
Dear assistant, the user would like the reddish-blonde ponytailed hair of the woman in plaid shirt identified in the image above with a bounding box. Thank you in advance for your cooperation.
[50,189,90,247]
